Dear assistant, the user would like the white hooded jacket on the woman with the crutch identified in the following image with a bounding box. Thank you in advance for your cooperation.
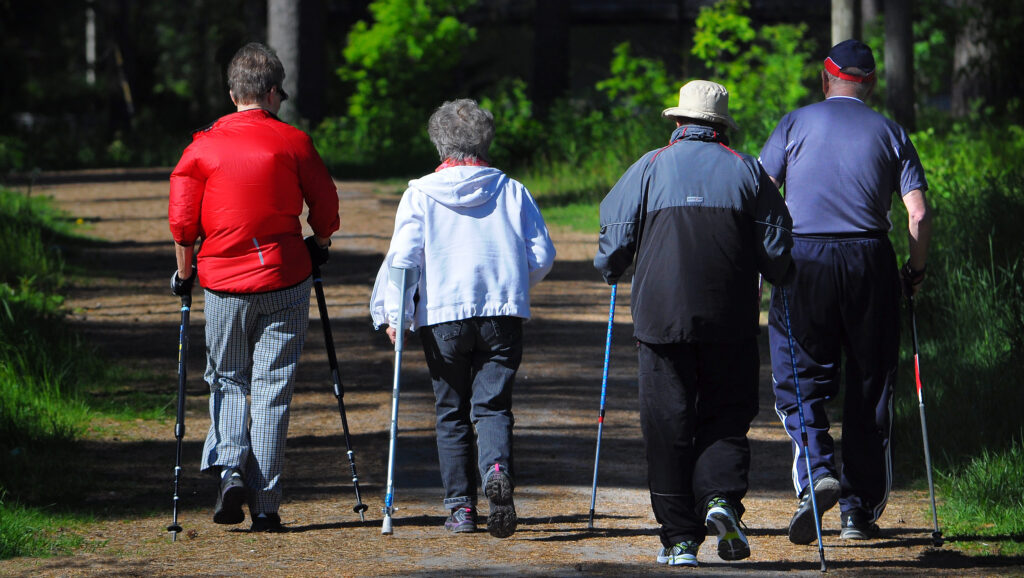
[370,166,555,329]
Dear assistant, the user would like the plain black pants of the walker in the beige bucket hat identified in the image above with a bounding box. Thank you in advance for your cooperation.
[639,339,759,547]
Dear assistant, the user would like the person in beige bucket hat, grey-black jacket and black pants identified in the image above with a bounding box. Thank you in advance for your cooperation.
[594,80,793,566]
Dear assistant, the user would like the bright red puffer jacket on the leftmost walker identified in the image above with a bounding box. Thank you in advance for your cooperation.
[168,109,340,293]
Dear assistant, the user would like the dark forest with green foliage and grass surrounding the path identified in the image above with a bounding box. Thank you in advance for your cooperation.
[0,0,1024,558]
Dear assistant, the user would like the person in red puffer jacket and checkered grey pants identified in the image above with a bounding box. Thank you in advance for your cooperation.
[168,42,339,532]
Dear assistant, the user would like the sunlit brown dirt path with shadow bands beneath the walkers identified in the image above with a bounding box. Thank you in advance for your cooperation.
[0,181,1007,576]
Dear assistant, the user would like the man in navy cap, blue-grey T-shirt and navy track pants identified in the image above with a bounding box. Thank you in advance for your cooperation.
[760,40,931,544]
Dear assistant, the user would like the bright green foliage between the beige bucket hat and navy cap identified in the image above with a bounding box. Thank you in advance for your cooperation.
[691,0,818,155]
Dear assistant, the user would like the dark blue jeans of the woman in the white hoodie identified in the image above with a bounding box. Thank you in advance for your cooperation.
[420,317,522,508]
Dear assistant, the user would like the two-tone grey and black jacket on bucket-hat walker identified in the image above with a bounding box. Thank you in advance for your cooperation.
[594,125,793,343]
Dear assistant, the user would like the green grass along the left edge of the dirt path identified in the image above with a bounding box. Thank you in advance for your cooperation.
[0,190,176,559]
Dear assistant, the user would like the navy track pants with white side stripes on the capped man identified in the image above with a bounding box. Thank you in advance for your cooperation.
[768,236,900,522]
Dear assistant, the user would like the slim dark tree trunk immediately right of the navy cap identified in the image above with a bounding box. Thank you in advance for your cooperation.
[886,0,915,131]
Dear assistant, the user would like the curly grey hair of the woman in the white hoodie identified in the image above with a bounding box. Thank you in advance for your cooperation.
[427,98,495,161]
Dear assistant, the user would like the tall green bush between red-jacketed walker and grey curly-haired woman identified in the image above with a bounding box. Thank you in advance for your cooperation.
[316,0,476,171]
